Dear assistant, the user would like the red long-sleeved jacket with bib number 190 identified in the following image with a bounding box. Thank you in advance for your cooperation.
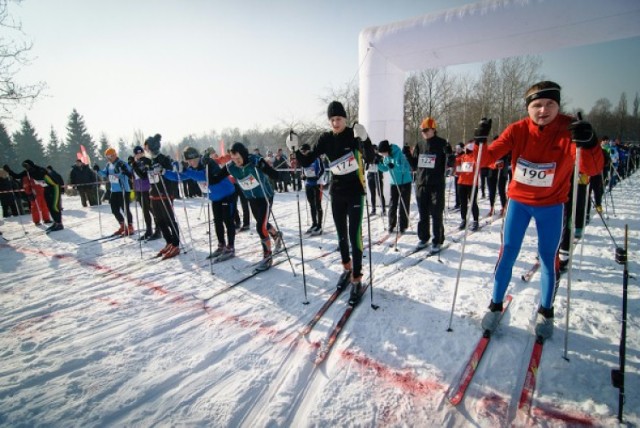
[482,114,604,206]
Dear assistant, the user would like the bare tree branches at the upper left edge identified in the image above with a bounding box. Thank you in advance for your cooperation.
[0,0,45,117]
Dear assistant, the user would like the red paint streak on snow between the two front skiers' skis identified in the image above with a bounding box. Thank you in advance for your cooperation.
[341,349,446,395]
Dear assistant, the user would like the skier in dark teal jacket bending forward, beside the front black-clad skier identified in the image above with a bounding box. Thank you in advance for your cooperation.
[217,142,283,271]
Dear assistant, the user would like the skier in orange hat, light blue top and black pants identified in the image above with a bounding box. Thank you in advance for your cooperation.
[98,147,133,236]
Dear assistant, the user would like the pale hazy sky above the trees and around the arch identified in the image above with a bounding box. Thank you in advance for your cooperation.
[3,0,640,144]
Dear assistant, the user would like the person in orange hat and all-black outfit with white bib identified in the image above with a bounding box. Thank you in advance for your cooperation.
[404,117,450,253]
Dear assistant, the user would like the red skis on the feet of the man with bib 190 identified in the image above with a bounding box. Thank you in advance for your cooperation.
[447,295,544,414]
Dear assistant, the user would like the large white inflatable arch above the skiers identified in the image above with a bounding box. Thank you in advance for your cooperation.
[358,0,640,145]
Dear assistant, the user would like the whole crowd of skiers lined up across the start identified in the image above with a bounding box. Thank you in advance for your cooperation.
[0,81,639,338]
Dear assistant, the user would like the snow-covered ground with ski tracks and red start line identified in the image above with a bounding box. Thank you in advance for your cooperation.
[0,174,640,427]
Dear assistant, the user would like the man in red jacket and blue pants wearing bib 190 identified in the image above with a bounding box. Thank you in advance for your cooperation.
[474,81,603,339]
